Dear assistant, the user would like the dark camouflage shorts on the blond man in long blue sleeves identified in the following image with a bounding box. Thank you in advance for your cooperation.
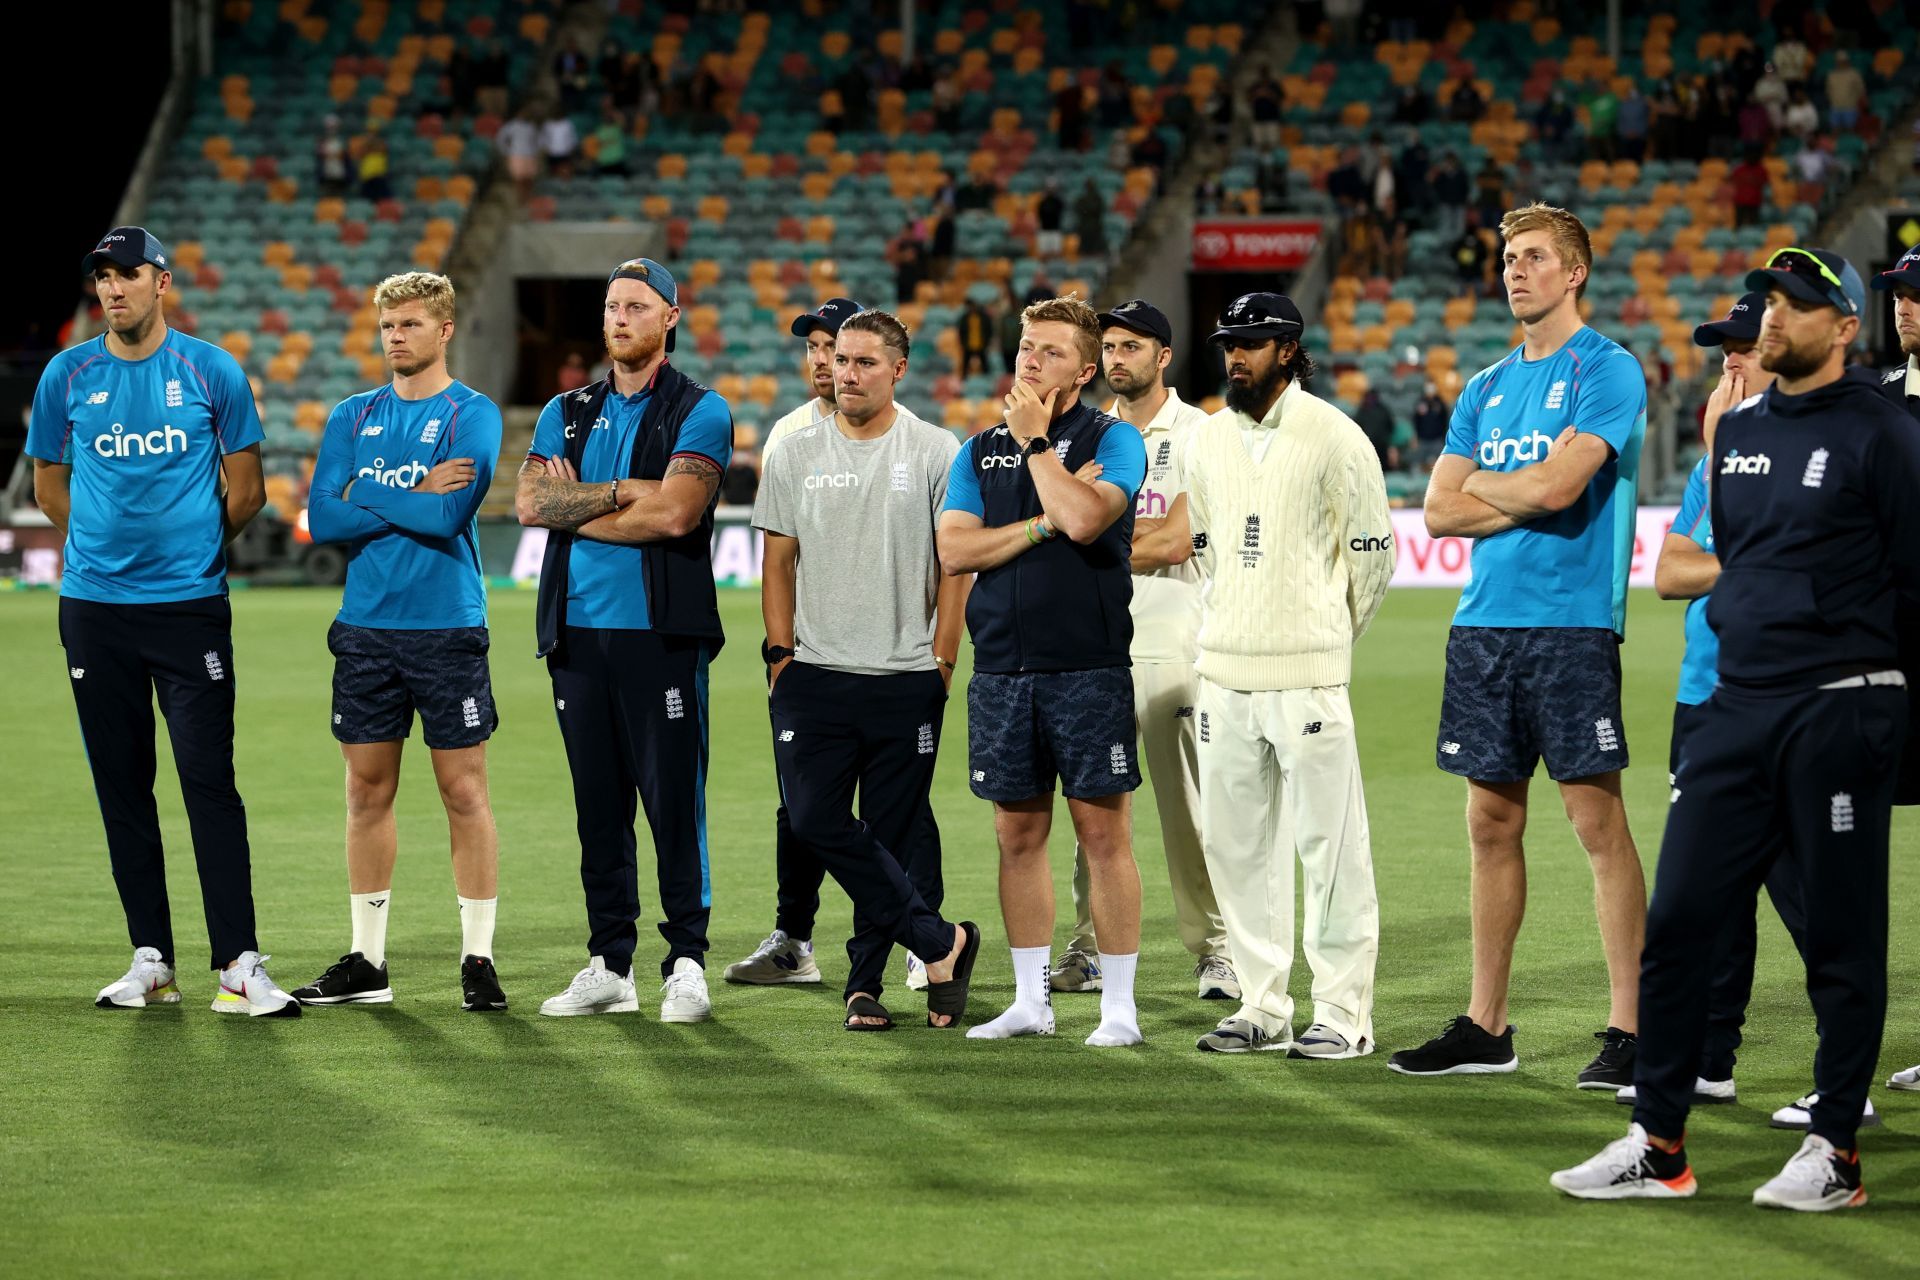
[326,622,499,750]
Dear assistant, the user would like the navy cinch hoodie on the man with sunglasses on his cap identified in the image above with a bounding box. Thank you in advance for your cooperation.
[1707,370,1920,691]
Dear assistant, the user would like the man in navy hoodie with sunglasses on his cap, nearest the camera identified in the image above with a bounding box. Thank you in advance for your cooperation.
[1551,248,1920,1211]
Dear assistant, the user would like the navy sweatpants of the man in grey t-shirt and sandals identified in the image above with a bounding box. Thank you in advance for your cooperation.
[772,662,954,998]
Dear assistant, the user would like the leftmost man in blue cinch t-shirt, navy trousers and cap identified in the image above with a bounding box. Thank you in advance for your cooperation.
[27,226,300,1017]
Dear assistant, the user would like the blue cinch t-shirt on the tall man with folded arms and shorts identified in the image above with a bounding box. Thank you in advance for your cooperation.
[1446,326,1647,635]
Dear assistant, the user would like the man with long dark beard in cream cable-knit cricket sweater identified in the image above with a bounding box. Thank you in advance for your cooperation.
[1150,294,1394,1057]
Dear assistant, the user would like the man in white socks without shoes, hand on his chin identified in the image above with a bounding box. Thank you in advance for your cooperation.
[939,297,1146,1048]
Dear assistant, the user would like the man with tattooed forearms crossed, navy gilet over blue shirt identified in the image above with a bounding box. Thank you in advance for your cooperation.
[515,257,733,1023]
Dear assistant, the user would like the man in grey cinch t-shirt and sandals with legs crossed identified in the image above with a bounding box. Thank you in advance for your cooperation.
[753,311,979,1031]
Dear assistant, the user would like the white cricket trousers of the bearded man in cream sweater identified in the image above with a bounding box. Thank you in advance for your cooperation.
[1196,677,1380,1050]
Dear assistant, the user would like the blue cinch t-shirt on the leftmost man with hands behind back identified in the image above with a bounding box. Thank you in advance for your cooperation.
[27,330,261,604]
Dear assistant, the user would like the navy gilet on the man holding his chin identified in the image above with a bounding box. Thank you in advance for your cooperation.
[962,403,1133,674]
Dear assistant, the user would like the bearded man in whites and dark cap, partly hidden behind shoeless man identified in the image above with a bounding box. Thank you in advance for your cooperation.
[1048,297,1240,1000]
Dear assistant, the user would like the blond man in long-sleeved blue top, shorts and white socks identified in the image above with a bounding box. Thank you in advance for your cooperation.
[294,271,507,1011]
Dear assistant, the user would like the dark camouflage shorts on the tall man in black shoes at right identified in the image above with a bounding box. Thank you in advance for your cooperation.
[1434,628,1626,783]
